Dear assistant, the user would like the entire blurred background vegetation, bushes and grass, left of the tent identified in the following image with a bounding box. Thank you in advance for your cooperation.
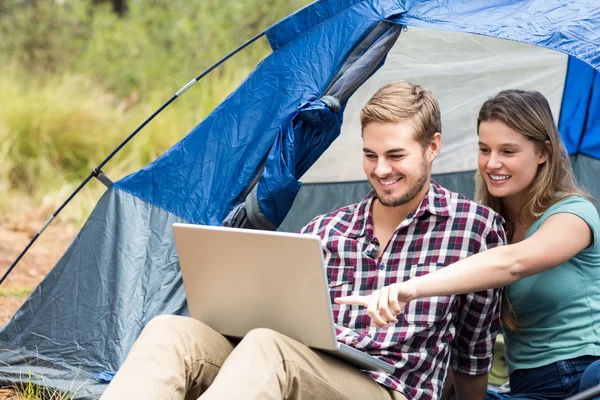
[0,0,309,220]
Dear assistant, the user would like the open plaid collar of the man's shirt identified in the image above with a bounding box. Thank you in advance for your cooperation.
[345,179,454,238]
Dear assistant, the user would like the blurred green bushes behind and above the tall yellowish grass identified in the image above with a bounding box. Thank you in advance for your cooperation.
[0,0,308,95]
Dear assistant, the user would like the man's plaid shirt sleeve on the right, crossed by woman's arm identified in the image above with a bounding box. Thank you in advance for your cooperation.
[451,215,506,375]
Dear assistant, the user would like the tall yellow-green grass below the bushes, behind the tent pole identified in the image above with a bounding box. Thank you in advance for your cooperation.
[0,60,255,222]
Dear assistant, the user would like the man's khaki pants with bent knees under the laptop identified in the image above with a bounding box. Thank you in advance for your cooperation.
[102,315,406,400]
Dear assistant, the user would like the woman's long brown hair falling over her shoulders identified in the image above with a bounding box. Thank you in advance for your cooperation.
[475,89,589,330]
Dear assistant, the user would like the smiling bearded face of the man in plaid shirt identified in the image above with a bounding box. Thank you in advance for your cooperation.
[363,122,437,207]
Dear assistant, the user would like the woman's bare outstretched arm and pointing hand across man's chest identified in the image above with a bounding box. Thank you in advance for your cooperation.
[335,213,593,326]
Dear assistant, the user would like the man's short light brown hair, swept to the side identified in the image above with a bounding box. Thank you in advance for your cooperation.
[360,81,442,148]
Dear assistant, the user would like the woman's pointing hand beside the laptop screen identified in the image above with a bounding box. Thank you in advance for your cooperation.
[334,281,416,328]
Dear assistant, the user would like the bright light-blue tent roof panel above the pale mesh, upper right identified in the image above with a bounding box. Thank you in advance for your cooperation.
[398,0,600,70]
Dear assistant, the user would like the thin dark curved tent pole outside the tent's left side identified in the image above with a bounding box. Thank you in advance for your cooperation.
[0,30,266,285]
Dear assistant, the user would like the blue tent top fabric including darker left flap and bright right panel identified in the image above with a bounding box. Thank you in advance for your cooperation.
[267,0,600,70]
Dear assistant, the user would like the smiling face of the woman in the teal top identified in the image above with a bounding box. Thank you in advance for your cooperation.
[478,121,546,199]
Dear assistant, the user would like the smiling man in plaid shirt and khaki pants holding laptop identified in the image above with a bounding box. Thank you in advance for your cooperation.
[103,82,505,400]
